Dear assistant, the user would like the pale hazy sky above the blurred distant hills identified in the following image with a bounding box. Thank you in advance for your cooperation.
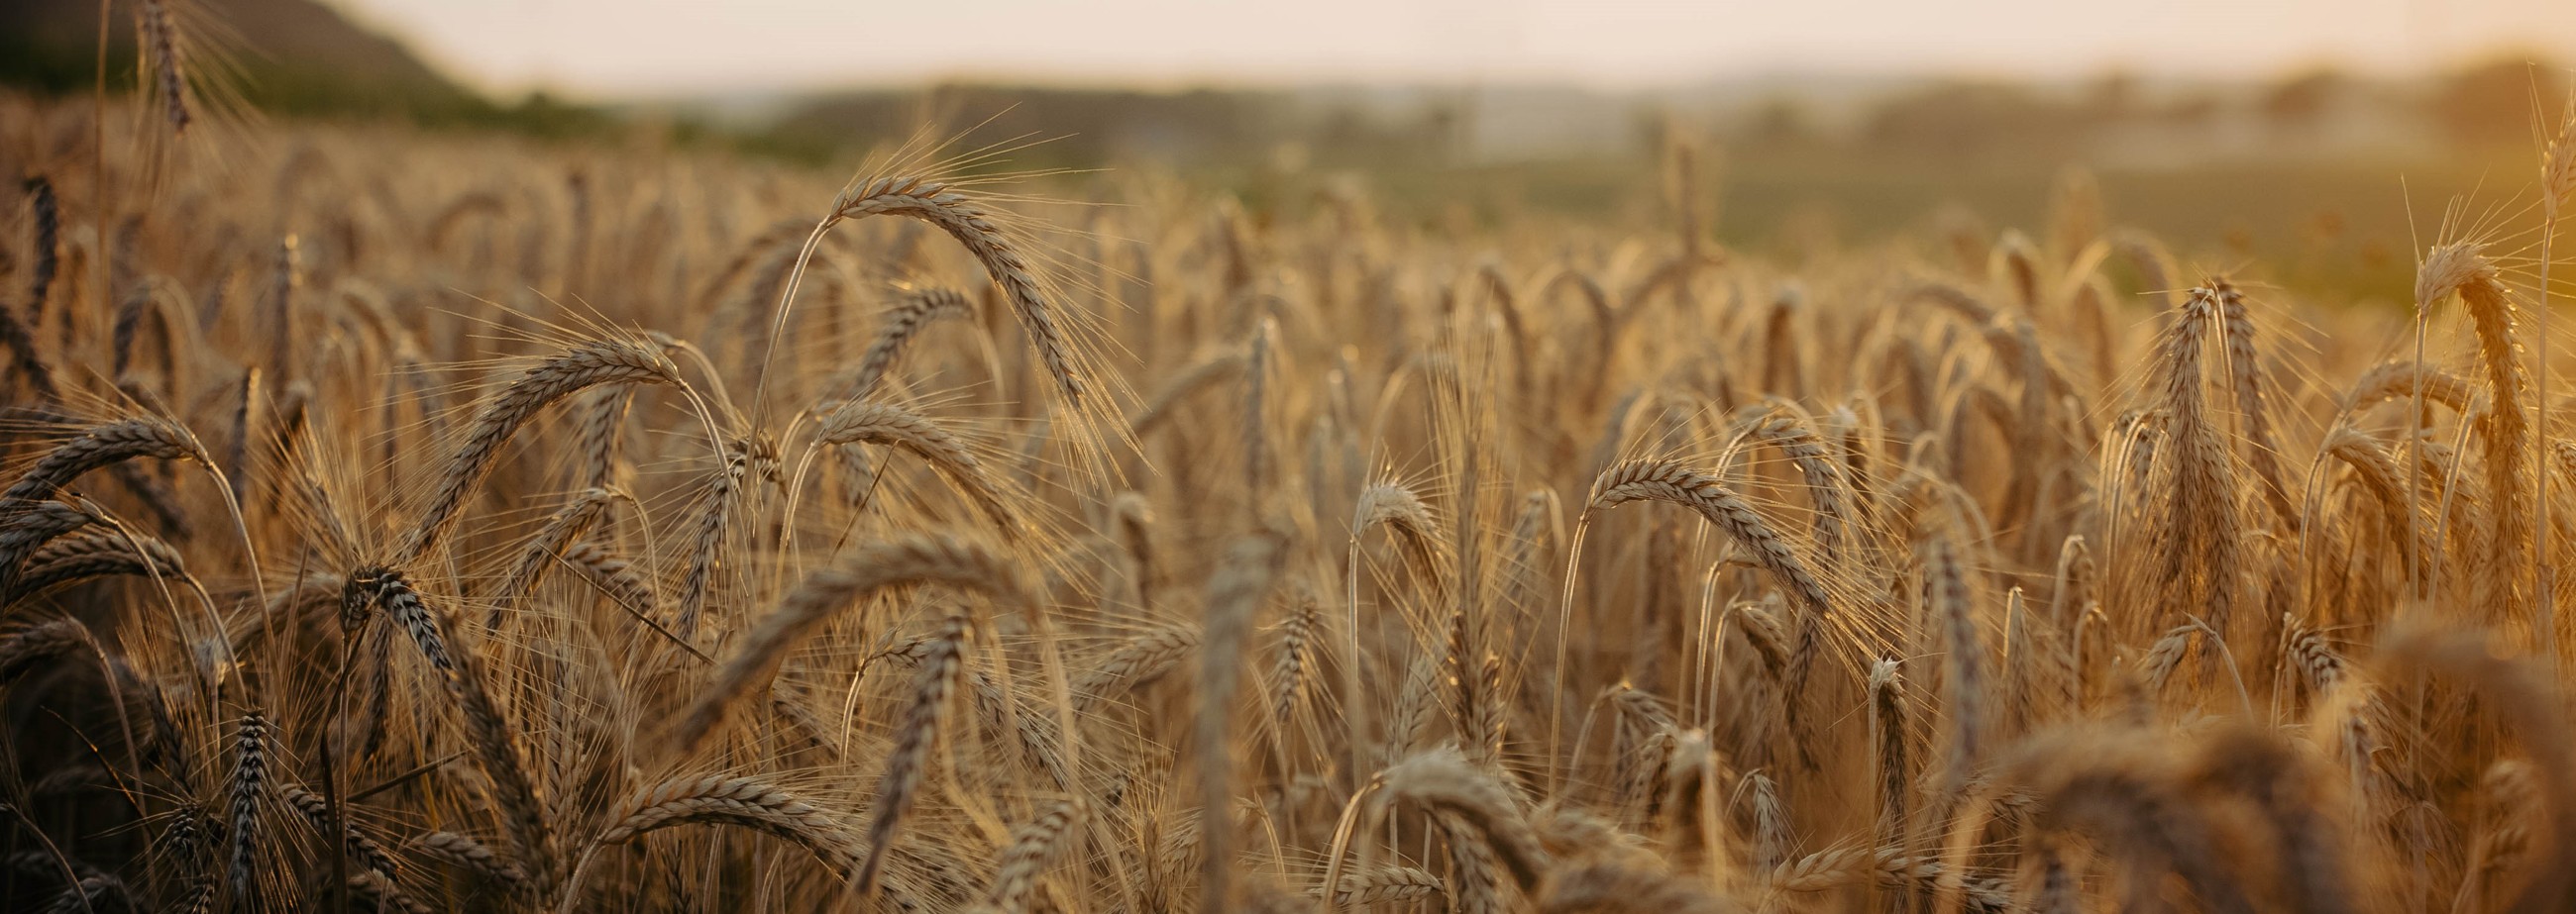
[330,0,2576,98]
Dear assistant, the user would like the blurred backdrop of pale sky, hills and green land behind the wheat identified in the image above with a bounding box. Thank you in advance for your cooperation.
[20,0,2576,306]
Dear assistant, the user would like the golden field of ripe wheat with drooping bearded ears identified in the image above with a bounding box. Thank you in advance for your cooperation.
[0,73,2576,914]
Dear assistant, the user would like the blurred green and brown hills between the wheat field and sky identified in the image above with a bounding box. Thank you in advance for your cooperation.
[0,0,2568,301]
